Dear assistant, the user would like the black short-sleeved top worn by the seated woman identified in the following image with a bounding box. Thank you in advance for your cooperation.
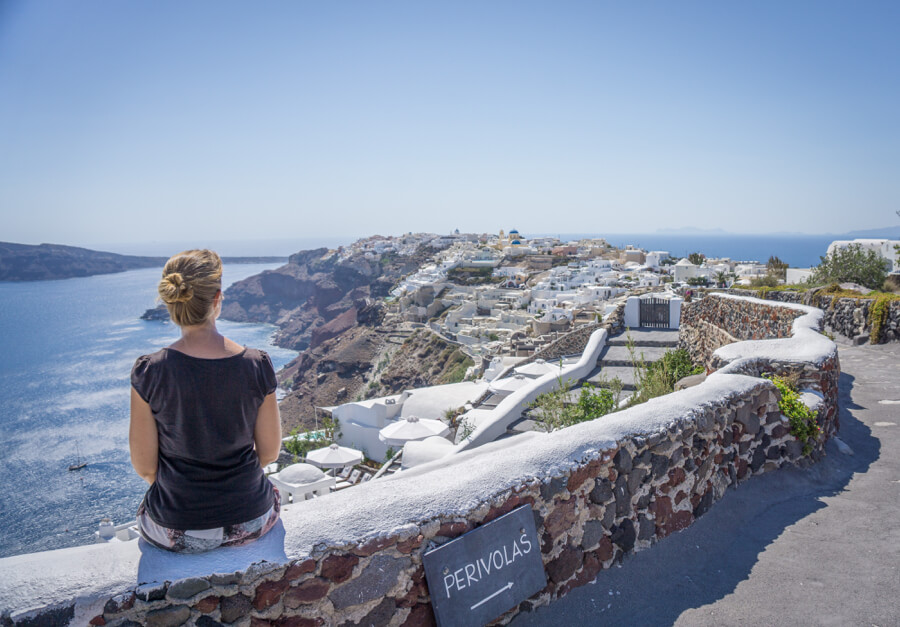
[131,348,276,530]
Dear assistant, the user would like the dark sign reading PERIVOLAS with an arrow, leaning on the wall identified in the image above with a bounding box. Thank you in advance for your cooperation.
[422,505,547,627]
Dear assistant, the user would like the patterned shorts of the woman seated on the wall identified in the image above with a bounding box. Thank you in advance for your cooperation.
[137,486,281,553]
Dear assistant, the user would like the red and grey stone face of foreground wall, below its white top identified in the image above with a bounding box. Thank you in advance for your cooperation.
[31,380,836,627]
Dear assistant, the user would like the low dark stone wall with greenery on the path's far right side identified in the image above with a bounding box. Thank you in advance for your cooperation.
[725,289,900,344]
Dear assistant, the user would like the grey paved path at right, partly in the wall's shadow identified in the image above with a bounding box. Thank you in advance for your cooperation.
[512,344,900,627]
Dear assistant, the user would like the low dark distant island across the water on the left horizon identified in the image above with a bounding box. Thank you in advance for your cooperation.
[0,242,286,281]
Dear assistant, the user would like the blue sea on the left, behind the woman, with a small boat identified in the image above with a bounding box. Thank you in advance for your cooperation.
[0,264,296,556]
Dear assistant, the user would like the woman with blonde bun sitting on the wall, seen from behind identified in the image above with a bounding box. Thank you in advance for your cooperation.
[129,250,281,553]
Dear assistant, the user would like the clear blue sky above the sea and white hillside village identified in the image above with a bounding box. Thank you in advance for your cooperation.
[0,0,900,250]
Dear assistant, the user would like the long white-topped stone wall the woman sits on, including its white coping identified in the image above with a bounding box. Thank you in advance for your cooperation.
[0,297,839,627]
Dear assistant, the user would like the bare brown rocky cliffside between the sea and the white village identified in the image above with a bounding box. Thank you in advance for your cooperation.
[222,248,446,430]
